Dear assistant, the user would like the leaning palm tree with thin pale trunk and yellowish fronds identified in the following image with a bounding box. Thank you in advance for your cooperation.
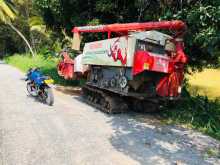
[0,0,35,56]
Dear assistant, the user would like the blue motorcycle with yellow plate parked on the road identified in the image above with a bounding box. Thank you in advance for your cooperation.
[26,68,54,106]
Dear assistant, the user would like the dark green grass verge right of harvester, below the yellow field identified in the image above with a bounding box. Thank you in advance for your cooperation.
[161,91,220,140]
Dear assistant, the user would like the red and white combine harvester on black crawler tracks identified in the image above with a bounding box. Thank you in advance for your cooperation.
[58,20,187,113]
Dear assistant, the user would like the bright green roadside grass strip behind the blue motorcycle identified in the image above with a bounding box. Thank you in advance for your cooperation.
[4,54,78,86]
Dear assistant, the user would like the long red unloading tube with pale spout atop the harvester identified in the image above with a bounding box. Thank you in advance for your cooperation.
[72,20,186,50]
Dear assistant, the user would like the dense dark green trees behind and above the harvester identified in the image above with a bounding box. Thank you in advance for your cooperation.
[0,0,220,69]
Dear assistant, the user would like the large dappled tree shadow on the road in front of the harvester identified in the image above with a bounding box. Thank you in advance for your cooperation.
[110,114,198,164]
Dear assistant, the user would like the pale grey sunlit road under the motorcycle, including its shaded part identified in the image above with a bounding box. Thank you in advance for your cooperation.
[0,62,220,165]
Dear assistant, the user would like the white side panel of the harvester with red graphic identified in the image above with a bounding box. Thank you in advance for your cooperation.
[82,36,134,66]
